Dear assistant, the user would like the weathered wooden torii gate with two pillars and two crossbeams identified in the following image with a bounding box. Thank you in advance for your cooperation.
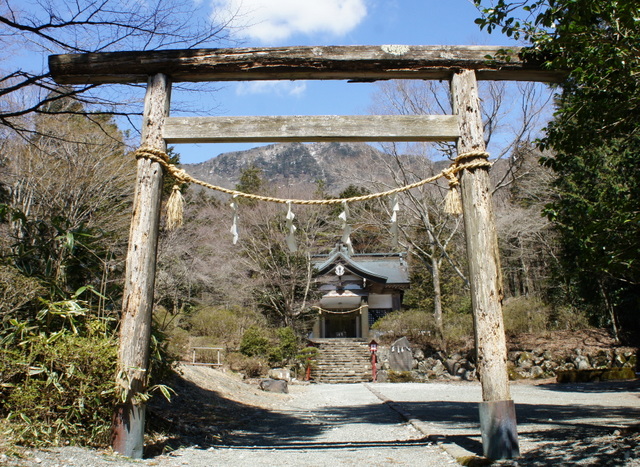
[49,45,562,459]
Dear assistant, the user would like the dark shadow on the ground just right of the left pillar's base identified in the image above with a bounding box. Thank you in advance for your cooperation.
[145,375,420,457]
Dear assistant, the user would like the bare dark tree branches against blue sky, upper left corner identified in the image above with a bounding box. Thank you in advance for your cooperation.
[0,0,228,132]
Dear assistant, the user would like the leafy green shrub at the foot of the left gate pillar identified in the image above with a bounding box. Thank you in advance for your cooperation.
[0,289,171,447]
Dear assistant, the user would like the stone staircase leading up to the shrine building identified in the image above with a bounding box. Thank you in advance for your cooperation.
[311,339,371,383]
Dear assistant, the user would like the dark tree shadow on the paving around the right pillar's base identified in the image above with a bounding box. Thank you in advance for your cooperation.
[390,394,640,466]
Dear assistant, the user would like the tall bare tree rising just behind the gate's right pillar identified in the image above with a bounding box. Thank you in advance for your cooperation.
[374,81,550,335]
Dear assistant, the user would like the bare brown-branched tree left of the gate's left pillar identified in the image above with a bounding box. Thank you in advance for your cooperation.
[2,100,135,310]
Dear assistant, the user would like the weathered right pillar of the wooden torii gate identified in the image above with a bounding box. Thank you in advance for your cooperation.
[451,70,520,459]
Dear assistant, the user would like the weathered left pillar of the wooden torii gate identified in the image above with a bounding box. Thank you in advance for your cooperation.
[113,74,171,458]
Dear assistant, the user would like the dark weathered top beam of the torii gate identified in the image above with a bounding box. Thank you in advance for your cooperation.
[49,45,564,84]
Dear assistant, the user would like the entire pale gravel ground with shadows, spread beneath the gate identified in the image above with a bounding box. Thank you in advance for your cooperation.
[6,366,640,467]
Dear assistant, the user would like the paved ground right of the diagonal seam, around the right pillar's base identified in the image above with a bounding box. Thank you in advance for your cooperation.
[368,381,640,467]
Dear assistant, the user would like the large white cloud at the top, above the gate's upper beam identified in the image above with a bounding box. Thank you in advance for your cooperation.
[212,0,367,44]
